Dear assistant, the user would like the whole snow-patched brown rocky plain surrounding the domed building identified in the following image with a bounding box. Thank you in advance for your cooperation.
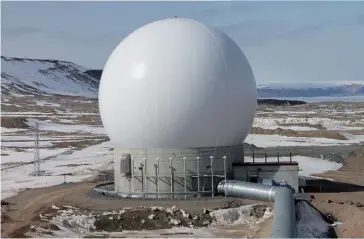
[1,95,364,237]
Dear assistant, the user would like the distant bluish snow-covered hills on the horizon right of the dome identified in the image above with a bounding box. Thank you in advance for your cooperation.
[258,82,364,98]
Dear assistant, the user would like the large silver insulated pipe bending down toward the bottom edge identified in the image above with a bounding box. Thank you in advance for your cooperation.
[217,180,297,238]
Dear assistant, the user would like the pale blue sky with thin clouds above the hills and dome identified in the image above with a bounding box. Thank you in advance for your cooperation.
[1,1,364,84]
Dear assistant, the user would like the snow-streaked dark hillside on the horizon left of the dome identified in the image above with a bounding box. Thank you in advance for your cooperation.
[1,56,99,97]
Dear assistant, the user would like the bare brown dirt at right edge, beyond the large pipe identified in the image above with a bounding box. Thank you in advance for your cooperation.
[312,147,364,238]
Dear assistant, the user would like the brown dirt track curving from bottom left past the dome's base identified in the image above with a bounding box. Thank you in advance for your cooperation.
[1,182,270,237]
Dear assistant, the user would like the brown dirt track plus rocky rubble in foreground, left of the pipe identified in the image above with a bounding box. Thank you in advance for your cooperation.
[2,180,270,237]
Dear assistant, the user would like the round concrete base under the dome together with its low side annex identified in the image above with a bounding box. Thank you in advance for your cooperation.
[114,145,299,199]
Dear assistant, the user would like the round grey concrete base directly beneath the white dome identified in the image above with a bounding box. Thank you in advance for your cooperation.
[114,145,244,198]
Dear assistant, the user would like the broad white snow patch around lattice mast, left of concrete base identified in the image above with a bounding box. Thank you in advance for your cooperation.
[1,142,113,199]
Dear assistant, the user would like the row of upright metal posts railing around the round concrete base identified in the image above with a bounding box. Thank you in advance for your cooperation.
[116,156,231,199]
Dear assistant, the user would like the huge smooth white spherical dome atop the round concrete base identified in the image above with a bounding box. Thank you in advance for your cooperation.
[99,18,257,149]
